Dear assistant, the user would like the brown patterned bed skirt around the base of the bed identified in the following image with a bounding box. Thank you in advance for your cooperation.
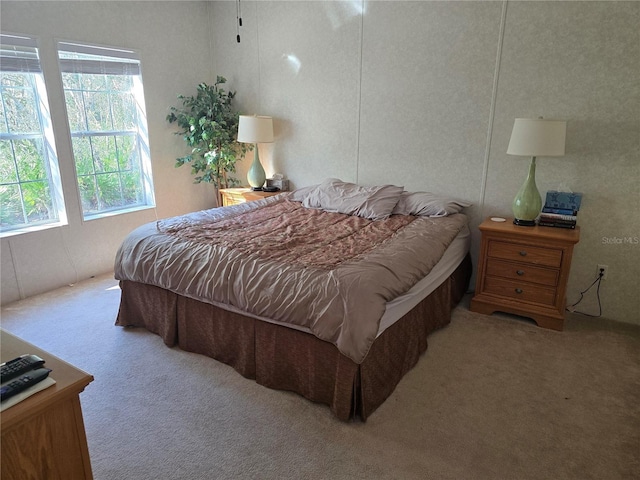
[116,255,471,421]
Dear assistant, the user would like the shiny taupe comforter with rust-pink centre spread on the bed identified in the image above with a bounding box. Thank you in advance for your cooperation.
[115,194,467,363]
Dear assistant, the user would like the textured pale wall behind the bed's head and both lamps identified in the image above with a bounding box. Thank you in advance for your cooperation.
[211,0,640,324]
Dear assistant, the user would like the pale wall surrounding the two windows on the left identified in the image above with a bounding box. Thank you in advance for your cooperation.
[0,0,215,304]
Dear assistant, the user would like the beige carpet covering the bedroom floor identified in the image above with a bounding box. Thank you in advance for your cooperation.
[2,275,640,480]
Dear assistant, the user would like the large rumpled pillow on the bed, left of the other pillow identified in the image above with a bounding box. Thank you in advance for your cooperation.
[302,178,404,220]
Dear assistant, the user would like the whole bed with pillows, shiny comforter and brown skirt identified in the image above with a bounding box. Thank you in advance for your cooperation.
[115,179,471,421]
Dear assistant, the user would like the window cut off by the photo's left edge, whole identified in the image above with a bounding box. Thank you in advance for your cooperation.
[0,34,66,232]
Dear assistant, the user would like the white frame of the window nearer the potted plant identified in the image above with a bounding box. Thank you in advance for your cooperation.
[57,41,155,220]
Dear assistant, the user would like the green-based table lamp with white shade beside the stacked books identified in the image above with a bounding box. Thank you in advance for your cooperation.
[507,117,567,226]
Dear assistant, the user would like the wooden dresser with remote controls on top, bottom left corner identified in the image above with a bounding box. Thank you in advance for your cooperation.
[0,330,93,480]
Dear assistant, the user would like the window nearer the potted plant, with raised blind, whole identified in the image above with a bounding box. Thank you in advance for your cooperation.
[58,42,153,219]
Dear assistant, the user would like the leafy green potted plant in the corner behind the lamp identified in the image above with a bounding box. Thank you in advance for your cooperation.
[167,76,253,189]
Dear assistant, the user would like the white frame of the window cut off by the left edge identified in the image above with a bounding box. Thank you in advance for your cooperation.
[0,33,68,237]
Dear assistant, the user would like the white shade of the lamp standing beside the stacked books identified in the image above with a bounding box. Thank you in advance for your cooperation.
[507,118,567,157]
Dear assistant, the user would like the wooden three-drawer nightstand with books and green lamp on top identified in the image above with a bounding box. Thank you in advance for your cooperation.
[471,219,580,330]
